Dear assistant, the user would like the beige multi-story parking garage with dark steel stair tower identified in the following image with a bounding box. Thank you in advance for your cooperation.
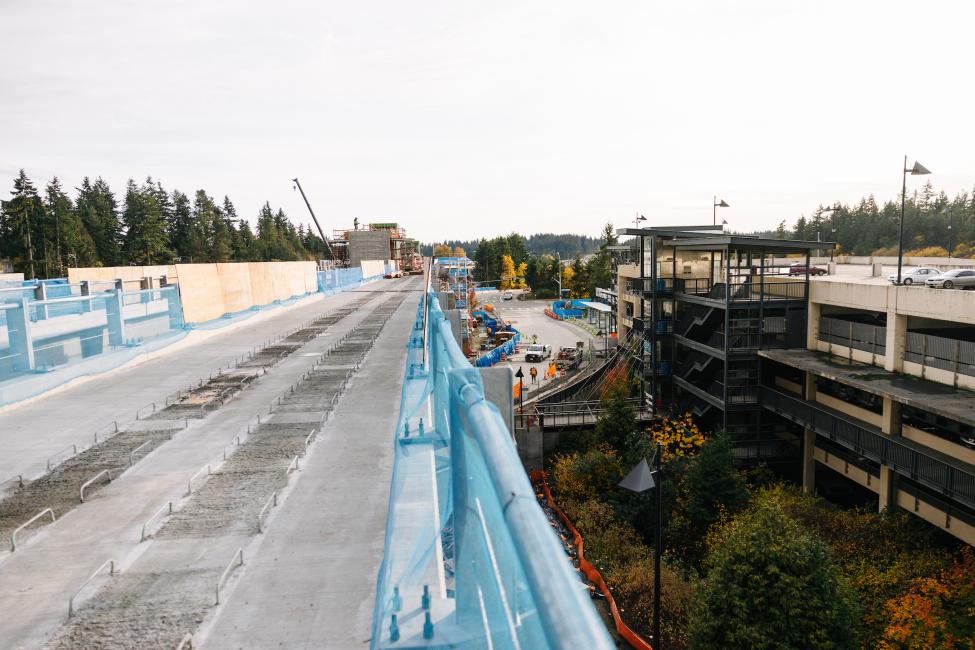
[616,226,975,543]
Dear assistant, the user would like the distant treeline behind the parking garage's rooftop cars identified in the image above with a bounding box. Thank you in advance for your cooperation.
[768,182,975,258]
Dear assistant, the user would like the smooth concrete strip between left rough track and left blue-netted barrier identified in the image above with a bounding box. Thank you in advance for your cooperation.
[0,280,403,481]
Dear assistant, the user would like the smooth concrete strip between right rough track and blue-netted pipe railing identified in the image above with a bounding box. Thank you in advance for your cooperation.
[203,294,420,649]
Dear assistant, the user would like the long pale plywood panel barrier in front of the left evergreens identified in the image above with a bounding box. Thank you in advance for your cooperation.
[68,262,320,323]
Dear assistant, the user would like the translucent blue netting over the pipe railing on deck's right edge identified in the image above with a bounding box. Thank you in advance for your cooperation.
[372,293,615,650]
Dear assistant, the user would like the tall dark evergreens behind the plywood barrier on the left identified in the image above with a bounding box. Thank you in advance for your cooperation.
[0,170,326,278]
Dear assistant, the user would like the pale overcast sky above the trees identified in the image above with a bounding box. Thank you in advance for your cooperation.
[0,0,975,241]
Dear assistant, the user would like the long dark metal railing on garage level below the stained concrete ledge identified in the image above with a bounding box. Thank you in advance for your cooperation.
[759,386,975,508]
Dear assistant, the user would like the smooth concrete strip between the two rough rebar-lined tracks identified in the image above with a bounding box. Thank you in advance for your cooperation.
[0,284,416,648]
